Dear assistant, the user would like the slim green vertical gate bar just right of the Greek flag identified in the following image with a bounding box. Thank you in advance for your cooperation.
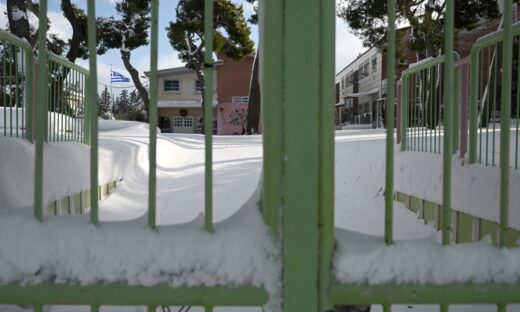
[148,0,159,229]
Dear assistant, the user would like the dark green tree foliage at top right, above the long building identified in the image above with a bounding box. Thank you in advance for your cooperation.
[338,0,502,56]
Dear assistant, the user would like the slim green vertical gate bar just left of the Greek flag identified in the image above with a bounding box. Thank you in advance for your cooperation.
[87,1,99,225]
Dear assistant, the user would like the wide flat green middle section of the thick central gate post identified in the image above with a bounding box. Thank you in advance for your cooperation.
[280,0,318,312]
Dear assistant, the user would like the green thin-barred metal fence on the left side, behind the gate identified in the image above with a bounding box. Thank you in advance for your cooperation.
[0,30,89,143]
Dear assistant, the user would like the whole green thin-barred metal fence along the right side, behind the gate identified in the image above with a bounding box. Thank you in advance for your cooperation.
[399,20,520,169]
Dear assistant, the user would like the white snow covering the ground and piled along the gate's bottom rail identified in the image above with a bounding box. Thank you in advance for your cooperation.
[0,121,520,311]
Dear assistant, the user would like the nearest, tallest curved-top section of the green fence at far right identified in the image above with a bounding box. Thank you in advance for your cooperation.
[469,24,520,169]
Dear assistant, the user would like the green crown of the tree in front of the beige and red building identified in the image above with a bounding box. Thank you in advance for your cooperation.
[166,0,254,69]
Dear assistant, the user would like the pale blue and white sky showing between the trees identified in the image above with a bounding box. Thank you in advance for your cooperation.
[0,0,366,91]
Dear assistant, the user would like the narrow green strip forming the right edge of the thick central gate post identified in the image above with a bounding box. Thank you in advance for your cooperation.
[318,1,335,311]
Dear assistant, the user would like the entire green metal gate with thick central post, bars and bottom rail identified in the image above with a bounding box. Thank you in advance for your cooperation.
[0,0,520,312]
